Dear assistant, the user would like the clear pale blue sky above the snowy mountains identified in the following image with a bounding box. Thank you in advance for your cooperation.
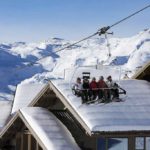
[0,0,150,42]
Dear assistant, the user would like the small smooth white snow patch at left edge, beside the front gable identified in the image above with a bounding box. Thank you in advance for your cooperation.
[0,101,12,130]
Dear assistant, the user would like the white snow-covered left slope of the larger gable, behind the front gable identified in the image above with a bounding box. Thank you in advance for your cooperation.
[11,83,47,113]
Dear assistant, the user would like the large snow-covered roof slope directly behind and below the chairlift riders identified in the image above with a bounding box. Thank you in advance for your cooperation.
[51,80,150,132]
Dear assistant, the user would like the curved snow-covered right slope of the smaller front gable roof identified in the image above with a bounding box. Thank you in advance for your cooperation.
[20,107,80,150]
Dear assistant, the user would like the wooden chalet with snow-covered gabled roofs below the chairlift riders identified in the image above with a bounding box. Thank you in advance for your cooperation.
[0,68,150,150]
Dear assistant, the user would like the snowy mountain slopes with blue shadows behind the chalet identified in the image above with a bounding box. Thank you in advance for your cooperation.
[0,29,150,100]
